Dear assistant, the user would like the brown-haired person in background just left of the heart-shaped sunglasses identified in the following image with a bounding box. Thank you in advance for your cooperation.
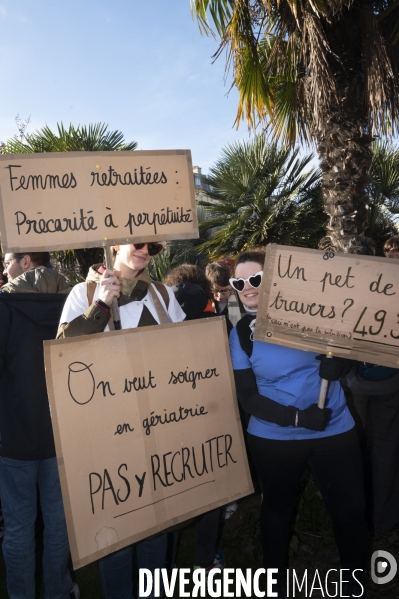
[205,261,244,332]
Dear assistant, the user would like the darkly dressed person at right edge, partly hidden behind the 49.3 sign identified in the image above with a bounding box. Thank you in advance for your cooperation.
[343,237,399,536]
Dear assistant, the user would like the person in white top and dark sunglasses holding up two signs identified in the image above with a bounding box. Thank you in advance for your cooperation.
[57,242,185,599]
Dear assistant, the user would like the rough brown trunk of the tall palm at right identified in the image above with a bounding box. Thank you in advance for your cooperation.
[316,7,372,254]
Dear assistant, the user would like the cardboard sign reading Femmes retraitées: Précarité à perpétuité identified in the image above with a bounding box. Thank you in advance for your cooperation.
[0,150,198,252]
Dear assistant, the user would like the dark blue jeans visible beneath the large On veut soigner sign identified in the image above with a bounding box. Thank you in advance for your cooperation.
[98,534,167,599]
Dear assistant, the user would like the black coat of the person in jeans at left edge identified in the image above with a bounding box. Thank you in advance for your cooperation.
[0,293,67,460]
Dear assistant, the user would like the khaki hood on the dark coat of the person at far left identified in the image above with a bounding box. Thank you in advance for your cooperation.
[0,266,72,295]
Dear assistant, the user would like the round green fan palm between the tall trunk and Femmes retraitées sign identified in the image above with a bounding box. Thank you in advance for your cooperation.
[195,134,325,260]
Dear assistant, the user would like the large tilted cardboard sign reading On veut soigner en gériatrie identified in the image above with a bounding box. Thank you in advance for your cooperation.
[45,317,253,568]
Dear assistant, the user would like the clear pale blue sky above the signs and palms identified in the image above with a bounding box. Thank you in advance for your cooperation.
[0,0,256,172]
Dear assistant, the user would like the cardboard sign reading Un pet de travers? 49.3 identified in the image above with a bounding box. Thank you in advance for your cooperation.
[254,244,399,368]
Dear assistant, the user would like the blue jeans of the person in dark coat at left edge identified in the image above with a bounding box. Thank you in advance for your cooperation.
[0,457,73,599]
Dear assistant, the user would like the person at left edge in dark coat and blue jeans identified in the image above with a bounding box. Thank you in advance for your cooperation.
[0,252,80,599]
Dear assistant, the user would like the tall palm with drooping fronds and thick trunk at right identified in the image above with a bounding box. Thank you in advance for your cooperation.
[191,0,399,253]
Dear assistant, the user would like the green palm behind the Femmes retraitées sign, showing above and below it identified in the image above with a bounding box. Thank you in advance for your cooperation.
[0,123,137,282]
